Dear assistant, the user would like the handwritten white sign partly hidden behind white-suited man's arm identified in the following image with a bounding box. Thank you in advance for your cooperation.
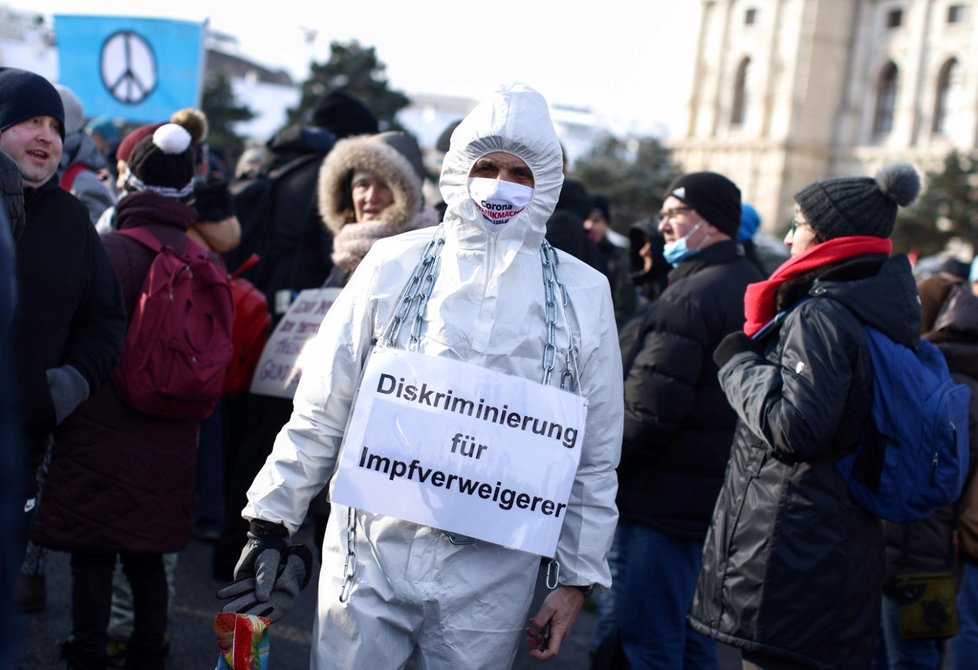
[251,288,340,398]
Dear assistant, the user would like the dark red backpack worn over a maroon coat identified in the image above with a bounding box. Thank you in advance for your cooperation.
[112,228,233,419]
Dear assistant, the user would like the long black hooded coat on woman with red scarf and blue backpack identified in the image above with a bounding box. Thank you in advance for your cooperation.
[690,255,920,668]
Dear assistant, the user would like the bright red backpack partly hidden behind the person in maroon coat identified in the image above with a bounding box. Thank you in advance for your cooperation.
[224,254,272,394]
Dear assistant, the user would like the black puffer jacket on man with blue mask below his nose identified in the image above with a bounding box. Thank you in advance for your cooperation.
[618,240,761,541]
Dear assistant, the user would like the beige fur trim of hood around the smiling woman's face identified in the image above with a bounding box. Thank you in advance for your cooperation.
[319,133,424,235]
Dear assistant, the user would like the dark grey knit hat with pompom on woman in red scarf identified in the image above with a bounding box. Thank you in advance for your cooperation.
[795,163,920,241]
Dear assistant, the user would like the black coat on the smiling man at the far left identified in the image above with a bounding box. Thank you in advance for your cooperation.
[17,178,126,484]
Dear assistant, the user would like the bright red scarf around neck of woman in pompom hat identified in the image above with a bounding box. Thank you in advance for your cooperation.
[744,235,893,342]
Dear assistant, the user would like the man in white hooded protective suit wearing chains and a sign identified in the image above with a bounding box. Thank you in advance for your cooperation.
[218,84,623,670]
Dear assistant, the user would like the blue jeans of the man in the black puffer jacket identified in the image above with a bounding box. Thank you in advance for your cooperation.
[614,522,717,670]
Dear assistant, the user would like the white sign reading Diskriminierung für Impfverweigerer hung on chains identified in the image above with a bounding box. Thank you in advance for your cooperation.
[330,348,587,556]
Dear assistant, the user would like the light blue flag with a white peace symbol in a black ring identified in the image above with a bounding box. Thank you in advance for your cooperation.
[54,14,207,123]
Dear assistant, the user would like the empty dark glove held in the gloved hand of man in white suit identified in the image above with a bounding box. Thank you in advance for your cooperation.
[217,544,312,622]
